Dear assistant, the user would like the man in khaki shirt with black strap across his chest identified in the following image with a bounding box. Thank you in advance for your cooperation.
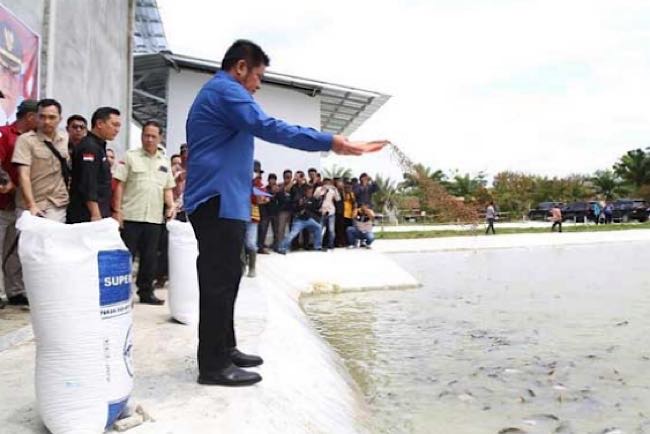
[11,99,69,223]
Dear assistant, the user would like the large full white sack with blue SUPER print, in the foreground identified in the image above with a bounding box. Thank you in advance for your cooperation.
[17,212,133,434]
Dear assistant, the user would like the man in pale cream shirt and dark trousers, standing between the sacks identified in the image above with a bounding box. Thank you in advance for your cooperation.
[113,121,176,305]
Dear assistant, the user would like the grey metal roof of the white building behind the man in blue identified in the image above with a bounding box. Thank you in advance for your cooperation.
[133,51,390,135]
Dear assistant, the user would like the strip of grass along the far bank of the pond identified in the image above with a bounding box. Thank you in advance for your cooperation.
[375,222,650,240]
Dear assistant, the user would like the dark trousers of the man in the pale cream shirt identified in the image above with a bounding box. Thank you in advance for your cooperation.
[122,221,163,296]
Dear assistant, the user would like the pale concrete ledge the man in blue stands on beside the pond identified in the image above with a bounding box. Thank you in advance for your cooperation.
[0,249,418,434]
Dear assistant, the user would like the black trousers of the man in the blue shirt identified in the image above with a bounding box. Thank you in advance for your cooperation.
[189,196,246,375]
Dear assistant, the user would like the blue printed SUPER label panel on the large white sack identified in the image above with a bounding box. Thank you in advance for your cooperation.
[97,250,131,306]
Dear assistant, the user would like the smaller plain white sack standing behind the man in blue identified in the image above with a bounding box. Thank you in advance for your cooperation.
[167,220,199,324]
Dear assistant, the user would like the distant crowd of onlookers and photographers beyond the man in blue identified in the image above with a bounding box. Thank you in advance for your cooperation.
[246,161,377,277]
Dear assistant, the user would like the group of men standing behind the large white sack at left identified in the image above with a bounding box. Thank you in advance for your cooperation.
[0,98,187,305]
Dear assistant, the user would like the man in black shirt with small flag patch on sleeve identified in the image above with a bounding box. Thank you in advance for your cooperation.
[67,107,122,223]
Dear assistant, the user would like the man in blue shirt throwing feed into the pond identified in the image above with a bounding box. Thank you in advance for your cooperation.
[184,40,386,386]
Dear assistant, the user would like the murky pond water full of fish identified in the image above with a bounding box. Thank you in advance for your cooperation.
[303,242,650,434]
